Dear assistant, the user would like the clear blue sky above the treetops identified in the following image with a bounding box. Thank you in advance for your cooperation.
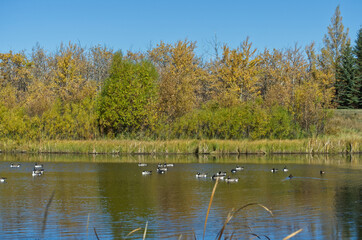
[0,0,362,57]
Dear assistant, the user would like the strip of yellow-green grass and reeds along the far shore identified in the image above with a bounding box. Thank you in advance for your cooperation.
[0,110,362,154]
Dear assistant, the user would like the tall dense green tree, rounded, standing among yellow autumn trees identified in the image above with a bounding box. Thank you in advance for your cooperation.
[98,52,158,135]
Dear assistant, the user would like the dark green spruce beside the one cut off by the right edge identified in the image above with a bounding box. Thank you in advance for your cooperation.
[335,43,359,108]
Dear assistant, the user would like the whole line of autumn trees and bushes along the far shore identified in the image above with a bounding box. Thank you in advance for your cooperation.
[0,7,362,140]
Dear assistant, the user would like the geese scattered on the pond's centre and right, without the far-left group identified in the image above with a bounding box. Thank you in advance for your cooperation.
[138,163,325,182]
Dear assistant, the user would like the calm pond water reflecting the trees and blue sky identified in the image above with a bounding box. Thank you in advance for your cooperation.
[0,154,362,239]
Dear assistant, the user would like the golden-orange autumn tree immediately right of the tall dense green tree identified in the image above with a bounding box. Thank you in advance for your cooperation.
[148,40,205,120]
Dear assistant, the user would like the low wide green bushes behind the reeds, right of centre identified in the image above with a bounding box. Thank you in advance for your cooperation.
[171,102,296,139]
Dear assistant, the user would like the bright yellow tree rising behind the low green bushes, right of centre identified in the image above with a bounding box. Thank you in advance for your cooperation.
[211,39,260,105]
